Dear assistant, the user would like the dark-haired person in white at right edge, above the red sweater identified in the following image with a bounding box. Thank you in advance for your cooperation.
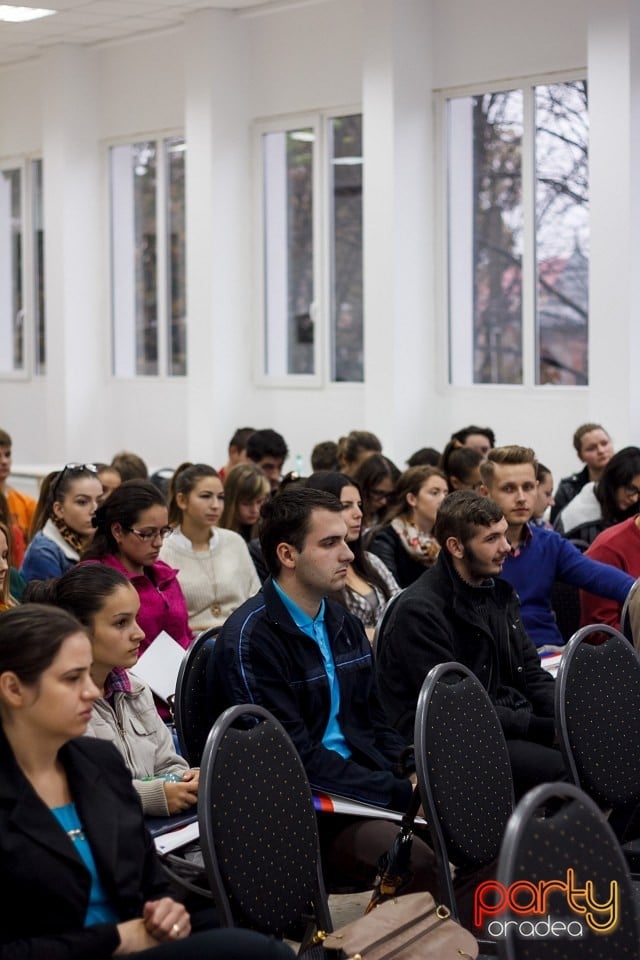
[554,447,640,543]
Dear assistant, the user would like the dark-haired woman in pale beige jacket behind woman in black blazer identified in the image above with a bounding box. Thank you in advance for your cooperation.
[26,564,198,817]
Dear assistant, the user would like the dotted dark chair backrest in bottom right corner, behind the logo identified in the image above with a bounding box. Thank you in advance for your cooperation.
[500,783,640,960]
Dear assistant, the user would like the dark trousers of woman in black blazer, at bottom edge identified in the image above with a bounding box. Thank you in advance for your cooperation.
[129,928,295,960]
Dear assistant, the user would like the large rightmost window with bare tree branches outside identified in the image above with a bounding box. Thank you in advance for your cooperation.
[446,79,589,385]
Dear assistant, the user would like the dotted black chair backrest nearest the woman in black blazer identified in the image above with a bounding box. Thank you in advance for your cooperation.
[198,704,331,936]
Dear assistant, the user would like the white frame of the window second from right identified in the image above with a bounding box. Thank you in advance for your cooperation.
[253,105,366,390]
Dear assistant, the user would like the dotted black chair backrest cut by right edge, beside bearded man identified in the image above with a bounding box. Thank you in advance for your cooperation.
[555,624,640,807]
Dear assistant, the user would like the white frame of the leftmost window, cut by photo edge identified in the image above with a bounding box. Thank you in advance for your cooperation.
[0,153,46,382]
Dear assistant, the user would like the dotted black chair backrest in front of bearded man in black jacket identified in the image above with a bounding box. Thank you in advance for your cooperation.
[415,663,514,910]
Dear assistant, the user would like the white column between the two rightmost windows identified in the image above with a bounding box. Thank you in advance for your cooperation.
[362,0,435,457]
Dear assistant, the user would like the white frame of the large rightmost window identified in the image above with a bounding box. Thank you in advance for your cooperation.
[435,68,589,395]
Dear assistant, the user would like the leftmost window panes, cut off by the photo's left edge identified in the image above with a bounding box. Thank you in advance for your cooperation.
[0,160,45,376]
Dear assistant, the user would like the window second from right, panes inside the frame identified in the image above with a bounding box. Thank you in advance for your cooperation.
[258,114,364,383]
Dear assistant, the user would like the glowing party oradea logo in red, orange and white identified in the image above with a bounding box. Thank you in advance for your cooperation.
[473,868,620,940]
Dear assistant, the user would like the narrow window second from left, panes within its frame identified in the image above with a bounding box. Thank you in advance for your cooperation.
[109,137,187,376]
